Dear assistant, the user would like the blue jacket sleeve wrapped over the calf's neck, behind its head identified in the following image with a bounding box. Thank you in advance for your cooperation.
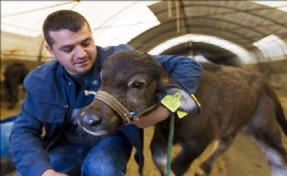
[154,55,202,94]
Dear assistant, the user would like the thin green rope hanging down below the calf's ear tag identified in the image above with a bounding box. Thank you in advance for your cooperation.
[166,113,174,176]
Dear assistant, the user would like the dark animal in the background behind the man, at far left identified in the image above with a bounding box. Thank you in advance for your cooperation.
[4,63,29,109]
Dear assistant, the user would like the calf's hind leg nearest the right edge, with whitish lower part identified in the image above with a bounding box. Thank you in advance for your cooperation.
[246,91,287,176]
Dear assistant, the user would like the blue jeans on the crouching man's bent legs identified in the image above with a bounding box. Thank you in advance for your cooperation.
[17,133,132,176]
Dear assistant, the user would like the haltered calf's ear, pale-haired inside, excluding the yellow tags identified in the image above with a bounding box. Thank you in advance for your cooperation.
[157,72,200,115]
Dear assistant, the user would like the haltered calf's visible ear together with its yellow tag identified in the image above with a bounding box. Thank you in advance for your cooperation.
[157,75,200,115]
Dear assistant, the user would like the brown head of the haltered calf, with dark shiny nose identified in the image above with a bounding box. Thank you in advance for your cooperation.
[77,50,201,136]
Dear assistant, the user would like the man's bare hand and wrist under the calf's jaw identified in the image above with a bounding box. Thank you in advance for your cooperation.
[132,106,170,128]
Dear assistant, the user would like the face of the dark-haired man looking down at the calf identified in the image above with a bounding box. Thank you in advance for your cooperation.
[46,24,97,75]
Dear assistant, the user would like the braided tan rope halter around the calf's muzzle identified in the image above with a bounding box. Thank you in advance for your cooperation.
[85,90,158,124]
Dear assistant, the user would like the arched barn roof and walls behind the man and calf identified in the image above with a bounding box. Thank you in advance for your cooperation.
[1,0,287,176]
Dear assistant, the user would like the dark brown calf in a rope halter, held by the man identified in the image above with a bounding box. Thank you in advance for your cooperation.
[78,51,287,176]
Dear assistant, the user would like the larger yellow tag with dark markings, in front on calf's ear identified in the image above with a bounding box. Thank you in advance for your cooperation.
[161,92,182,112]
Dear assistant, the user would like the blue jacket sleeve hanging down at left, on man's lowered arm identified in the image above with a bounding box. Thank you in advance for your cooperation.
[10,92,52,176]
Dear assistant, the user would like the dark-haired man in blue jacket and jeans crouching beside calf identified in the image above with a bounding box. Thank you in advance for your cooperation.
[10,10,202,176]
